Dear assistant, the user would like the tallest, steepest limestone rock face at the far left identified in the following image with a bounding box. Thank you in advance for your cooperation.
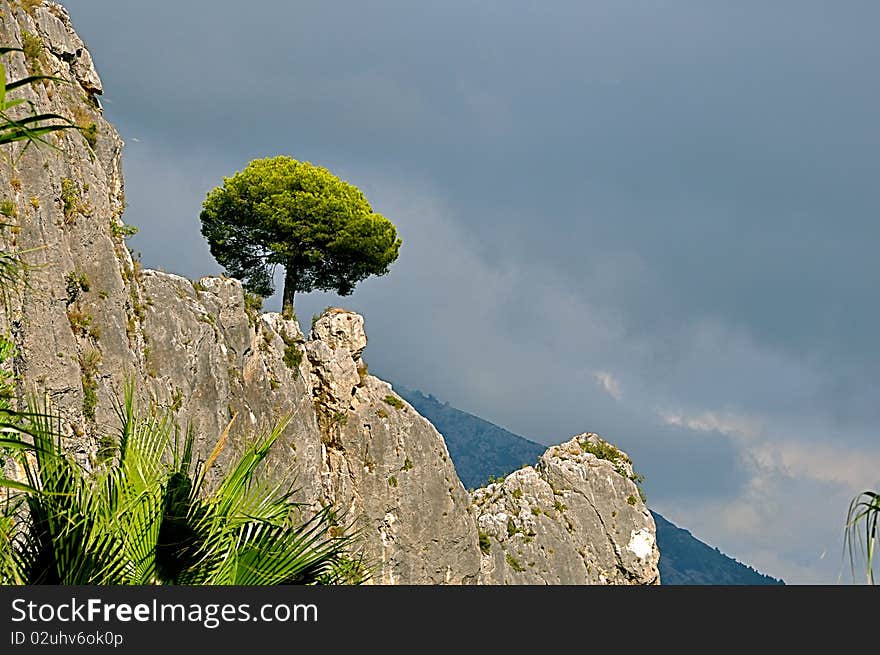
[0,0,132,464]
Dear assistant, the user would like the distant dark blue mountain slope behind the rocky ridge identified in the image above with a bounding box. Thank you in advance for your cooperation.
[394,384,784,585]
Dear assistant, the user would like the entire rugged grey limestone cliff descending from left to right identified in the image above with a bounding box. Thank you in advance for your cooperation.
[0,0,657,584]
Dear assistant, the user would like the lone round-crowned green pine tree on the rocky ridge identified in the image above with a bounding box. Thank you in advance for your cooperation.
[201,156,401,312]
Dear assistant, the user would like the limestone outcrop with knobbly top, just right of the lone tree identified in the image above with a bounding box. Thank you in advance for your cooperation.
[306,308,480,584]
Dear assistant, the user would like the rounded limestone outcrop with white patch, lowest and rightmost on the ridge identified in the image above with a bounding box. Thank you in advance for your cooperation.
[473,434,660,584]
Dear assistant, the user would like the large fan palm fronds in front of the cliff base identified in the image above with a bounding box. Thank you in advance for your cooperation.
[0,388,368,585]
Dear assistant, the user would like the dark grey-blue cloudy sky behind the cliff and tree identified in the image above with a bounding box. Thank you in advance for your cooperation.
[65,0,880,583]
